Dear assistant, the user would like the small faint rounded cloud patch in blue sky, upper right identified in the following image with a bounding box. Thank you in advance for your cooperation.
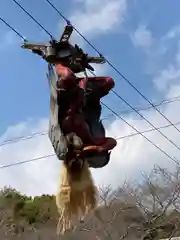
[131,24,154,50]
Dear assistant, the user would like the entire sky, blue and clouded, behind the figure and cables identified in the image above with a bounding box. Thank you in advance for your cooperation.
[0,0,180,194]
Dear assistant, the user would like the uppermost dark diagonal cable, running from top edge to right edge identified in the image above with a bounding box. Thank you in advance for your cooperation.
[45,0,180,135]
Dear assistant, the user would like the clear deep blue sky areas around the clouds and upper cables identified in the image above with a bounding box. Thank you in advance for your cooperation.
[0,0,180,133]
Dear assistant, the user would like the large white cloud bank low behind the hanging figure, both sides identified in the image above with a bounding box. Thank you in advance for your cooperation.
[0,81,180,195]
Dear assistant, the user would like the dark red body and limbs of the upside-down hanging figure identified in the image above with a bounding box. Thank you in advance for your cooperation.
[56,64,116,152]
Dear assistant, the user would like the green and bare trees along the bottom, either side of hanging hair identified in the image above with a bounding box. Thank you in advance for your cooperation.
[0,166,180,240]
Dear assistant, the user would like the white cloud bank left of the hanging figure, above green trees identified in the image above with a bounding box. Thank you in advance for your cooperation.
[0,119,59,195]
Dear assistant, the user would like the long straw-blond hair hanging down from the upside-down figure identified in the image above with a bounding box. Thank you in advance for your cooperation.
[56,151,97,235]
